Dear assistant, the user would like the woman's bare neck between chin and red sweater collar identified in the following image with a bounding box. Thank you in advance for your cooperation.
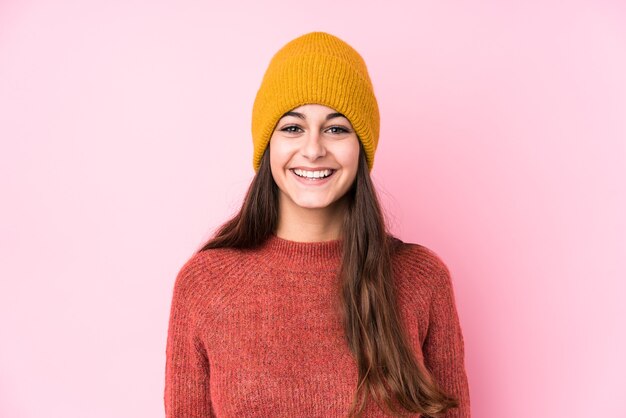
[275,193,347,242]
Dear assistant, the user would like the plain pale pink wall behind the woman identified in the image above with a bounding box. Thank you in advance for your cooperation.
[0,0,626,418]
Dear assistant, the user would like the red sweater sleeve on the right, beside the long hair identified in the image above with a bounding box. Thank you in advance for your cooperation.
[422,265,471,418]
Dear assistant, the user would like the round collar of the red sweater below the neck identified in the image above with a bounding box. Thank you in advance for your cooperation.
[252,233,343,271]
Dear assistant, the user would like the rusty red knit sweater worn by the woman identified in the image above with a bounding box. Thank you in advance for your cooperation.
[164,235,470,418]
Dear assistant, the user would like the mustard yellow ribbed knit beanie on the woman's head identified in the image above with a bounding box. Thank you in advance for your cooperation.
[252,31,380,171]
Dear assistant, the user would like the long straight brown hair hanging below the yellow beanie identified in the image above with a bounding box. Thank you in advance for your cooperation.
[198,141,458,417]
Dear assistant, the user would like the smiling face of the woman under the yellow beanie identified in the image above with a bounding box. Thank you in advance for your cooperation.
[269,104,359,209]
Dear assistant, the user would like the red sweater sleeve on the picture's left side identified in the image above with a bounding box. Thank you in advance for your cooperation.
[164,258,214,418]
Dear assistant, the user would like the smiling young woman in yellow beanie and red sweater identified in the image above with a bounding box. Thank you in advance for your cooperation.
[164,32,470,418]
